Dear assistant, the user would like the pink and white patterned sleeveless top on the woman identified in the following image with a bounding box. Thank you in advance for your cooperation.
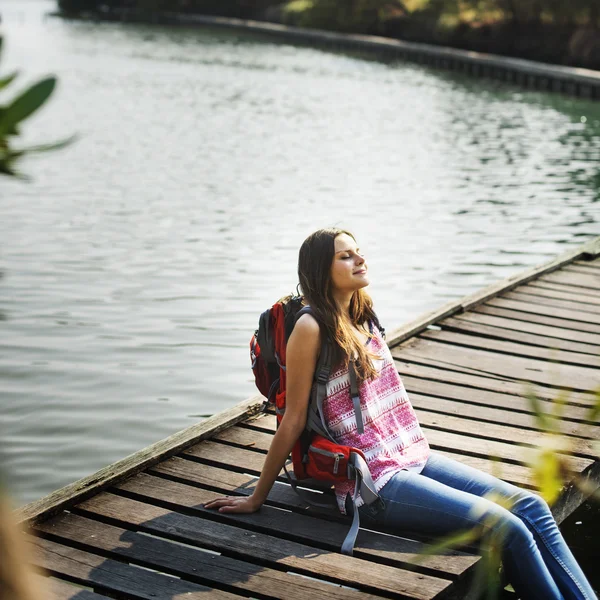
[323,326,429,514]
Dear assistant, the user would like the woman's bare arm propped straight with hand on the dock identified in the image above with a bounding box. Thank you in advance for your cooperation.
[205,314,321,513]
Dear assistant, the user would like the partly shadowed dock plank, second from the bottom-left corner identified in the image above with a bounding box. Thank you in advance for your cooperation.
[27,536,239,600]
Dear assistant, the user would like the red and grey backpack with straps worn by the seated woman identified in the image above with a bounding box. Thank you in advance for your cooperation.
[250,296,383,555]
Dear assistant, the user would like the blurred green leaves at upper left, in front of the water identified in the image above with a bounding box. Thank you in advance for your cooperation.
[0,37,74,177]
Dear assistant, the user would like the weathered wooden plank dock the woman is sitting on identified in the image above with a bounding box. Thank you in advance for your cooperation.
[19,238,600,600]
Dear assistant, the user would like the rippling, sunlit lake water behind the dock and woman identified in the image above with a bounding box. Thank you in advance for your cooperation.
[0,0,600,503]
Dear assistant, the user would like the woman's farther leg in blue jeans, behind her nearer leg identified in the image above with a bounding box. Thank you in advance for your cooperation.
[421,453,596,600]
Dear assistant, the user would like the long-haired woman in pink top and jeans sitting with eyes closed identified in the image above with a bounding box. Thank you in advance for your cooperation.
[206,229,596,600]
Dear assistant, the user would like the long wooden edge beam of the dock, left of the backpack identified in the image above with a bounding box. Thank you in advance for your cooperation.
[16,396,263,524]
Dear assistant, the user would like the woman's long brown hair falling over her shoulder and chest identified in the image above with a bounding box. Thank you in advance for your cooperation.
[298,228,377,381]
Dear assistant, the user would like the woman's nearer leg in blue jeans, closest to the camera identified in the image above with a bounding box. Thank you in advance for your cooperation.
[360,463,564,600]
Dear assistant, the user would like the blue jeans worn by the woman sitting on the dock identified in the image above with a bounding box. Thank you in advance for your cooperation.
[359,452,597,600]
